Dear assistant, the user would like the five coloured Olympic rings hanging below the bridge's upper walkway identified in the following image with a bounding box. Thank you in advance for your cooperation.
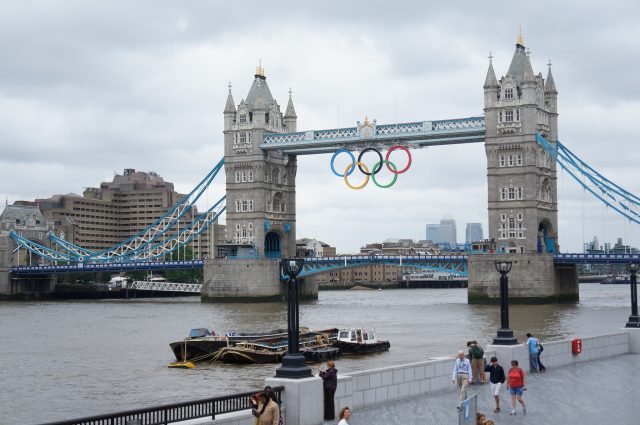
[331,145,413,190]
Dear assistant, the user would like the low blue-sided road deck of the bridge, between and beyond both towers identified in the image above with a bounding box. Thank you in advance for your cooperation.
[11,250,640,277]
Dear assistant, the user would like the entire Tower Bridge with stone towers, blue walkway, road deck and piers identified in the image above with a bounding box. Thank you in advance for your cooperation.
[5,37,640,303]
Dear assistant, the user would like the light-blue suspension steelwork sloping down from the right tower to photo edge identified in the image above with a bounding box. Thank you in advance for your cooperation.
[536,134,640,224]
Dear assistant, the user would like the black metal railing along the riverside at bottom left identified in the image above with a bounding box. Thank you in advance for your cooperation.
[42,387,284,425]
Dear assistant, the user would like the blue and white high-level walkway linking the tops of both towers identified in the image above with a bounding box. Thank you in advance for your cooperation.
[260,117,486,155]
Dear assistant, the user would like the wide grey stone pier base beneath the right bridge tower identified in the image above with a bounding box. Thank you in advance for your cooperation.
[468,253,579,304]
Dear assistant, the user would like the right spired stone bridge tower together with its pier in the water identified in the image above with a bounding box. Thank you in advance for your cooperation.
[469,36,578,303]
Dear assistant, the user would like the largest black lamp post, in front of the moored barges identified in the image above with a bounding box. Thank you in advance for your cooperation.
[276,258,313,379]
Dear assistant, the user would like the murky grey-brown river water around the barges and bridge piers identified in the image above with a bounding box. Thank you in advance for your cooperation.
[0,283,630,425]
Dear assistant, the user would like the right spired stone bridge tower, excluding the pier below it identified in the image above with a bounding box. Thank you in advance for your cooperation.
[484,35,558,253]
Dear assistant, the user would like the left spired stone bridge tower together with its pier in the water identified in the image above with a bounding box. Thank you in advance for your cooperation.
[202,65,317,302]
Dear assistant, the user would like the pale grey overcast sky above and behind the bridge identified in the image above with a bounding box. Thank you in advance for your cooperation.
[0,0,640,252]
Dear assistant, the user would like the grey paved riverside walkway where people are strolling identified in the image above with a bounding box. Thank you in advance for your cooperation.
[325,354,640,425]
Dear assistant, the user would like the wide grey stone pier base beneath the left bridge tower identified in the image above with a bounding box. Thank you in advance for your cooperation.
[201,258,318,303]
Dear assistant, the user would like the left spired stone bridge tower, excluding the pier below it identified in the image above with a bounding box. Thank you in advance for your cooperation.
[218,65,297,258]
